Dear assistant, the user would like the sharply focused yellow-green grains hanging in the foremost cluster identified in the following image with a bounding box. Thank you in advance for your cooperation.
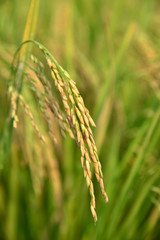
[47,55,108,221]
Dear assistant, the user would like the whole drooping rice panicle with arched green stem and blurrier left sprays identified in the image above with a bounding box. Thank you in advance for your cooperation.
[9,40,108,222]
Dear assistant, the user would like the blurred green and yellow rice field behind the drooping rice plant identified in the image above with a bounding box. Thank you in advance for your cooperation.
[0,0,160,240]
